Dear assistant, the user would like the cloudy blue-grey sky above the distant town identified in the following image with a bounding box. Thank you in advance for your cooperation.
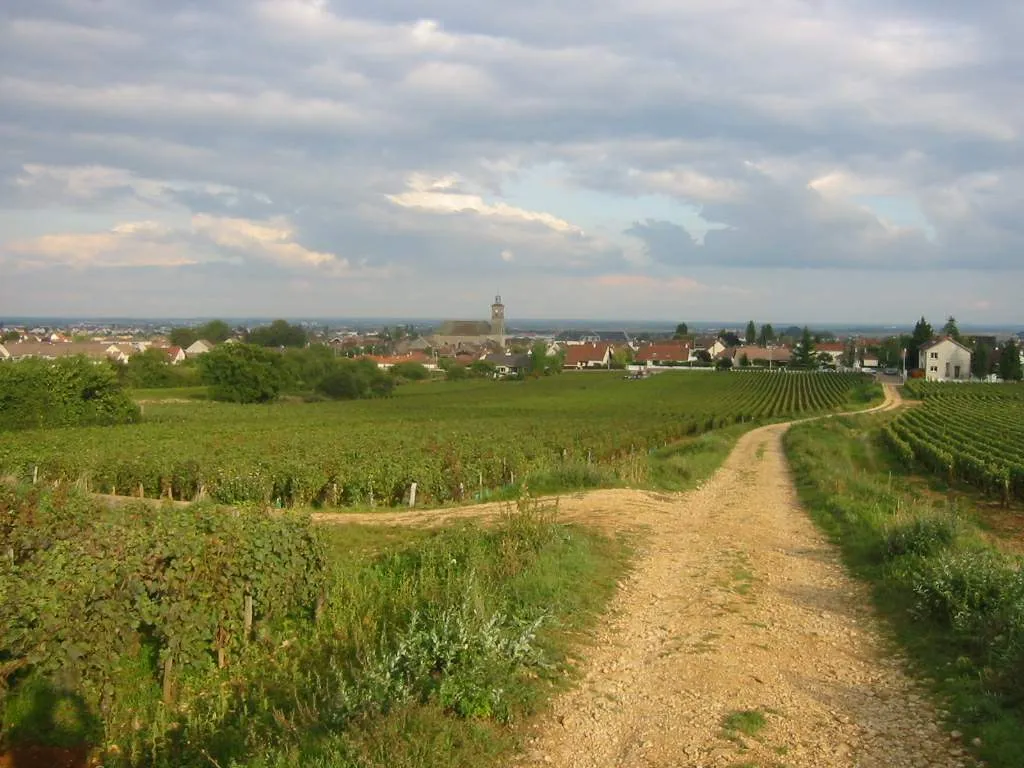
[0,0,1024,325]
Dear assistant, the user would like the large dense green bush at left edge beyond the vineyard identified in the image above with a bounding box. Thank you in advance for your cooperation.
[0,357,139,430]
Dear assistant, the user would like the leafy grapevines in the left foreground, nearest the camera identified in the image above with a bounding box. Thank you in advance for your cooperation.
[0,486,326,745]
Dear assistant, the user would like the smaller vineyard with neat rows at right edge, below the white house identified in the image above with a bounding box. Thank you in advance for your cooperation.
[884,382,1024,503]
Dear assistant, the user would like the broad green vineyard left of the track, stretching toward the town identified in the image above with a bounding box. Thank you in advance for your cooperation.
[0,373,873,507]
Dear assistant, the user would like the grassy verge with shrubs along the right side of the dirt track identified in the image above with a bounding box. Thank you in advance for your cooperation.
[785,419,1024,768]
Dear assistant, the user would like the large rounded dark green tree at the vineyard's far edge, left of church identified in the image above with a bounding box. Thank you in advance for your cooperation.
[199,344,287,402]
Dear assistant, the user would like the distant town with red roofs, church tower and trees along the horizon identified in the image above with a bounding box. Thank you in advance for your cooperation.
[0,296,1024,380]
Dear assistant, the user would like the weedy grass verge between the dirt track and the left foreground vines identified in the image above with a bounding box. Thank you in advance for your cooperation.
[0,501,629,768]
